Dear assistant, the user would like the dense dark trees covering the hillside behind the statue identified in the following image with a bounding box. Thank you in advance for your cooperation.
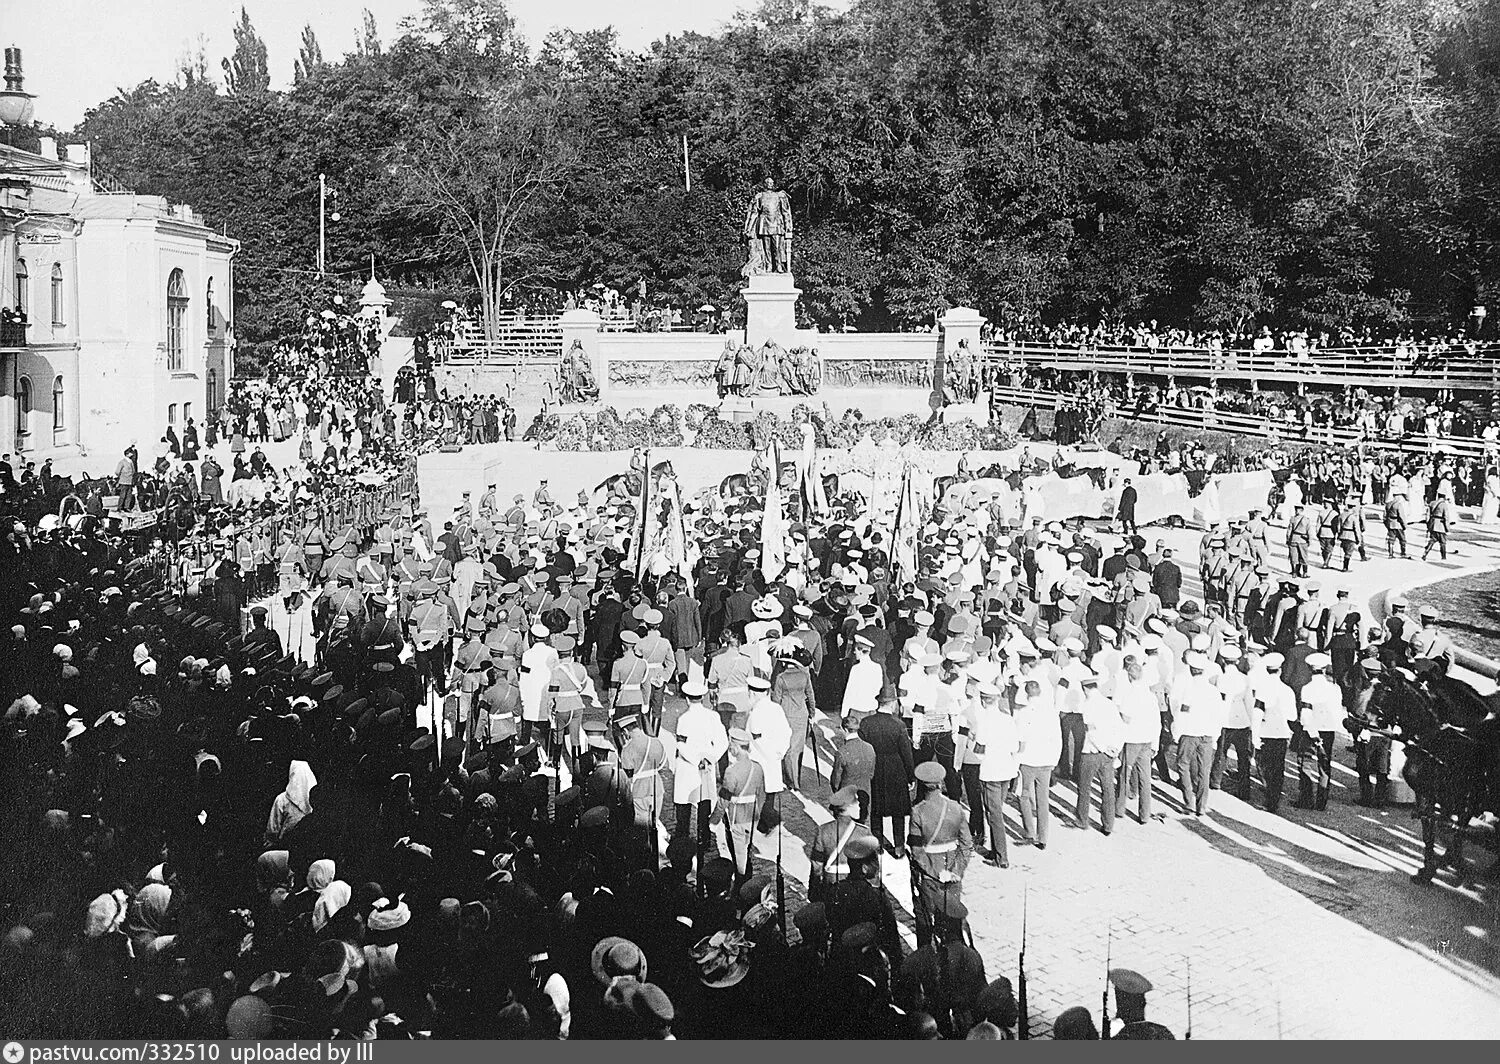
[64,0,1500,341]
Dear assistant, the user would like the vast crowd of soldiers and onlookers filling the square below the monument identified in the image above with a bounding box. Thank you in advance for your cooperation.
[11,303,1500,1040]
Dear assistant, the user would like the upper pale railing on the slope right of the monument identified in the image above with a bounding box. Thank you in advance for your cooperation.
[986,341,1500,390]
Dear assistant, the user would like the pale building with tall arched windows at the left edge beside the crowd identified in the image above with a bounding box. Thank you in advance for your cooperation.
[0,143,239,474]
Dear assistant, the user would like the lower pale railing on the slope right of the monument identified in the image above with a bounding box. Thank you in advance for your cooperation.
[992,387,1485,458]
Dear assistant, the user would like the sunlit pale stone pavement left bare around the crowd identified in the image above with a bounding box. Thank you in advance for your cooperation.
[411,449,1500,1038]
